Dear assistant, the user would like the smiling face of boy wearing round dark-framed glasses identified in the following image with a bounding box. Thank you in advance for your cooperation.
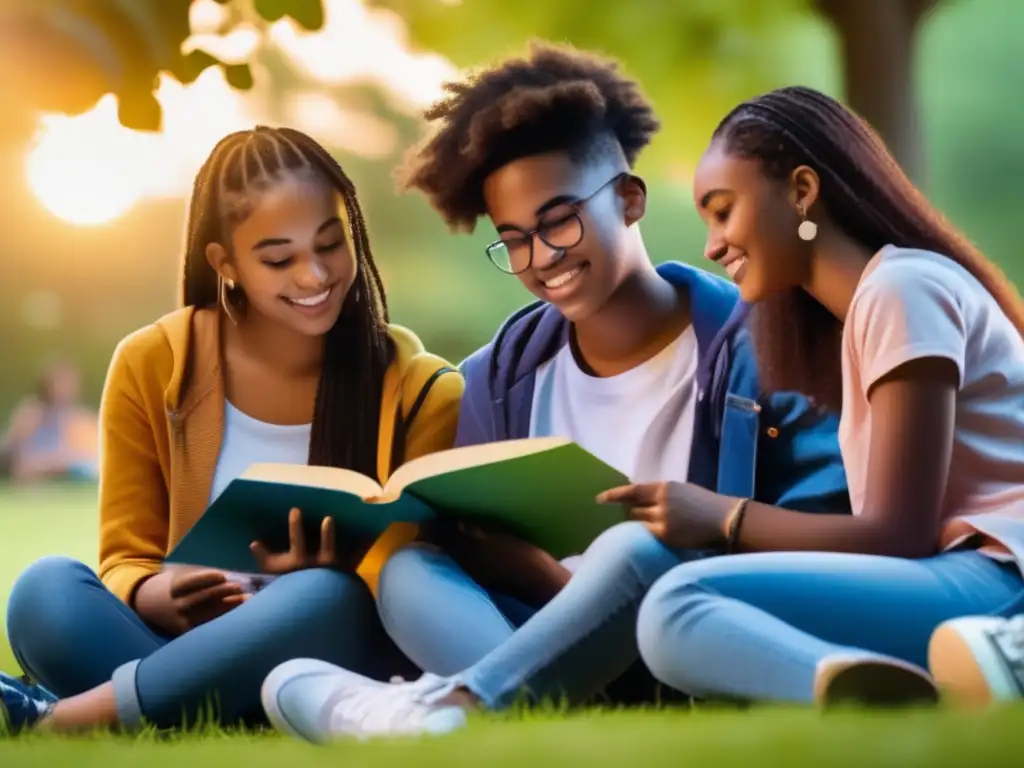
[483,153,646,322]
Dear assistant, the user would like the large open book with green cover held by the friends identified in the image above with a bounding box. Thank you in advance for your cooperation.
[167,437,629,572]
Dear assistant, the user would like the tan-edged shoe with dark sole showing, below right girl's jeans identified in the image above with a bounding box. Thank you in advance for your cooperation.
[814,654,939,708]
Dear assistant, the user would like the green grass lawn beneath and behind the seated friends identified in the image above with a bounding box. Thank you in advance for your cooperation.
[0,486,1024,768]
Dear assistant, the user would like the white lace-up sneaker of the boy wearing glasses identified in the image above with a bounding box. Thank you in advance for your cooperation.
[260,658,466,743]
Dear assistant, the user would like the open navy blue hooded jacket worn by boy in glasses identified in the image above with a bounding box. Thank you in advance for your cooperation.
[456,262,850,512]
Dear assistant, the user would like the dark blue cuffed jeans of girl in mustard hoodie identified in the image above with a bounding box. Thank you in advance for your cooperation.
[7,557,416,728]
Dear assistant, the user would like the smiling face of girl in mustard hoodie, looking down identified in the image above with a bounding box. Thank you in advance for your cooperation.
[207,173,357,336]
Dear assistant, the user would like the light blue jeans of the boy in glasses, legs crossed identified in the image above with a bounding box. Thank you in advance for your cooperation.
[378,522,698,709]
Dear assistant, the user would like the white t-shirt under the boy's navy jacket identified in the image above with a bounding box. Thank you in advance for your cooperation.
[529,326,697,482]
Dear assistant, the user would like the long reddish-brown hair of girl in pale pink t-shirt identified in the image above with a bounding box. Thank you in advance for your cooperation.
[713,86,1024,411]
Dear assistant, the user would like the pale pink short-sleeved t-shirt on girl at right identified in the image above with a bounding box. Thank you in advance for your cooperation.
[839,246,1024,536]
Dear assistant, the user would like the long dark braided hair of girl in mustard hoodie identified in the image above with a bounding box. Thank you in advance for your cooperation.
[181,126,394,477]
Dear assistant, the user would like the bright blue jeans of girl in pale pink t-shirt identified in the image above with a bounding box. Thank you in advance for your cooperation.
[637,551,1024,702]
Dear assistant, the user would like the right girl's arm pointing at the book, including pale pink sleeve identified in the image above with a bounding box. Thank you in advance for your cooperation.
[601,264,975,558]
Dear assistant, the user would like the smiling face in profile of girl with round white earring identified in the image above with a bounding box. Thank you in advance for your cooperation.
[693,140,810,302]
